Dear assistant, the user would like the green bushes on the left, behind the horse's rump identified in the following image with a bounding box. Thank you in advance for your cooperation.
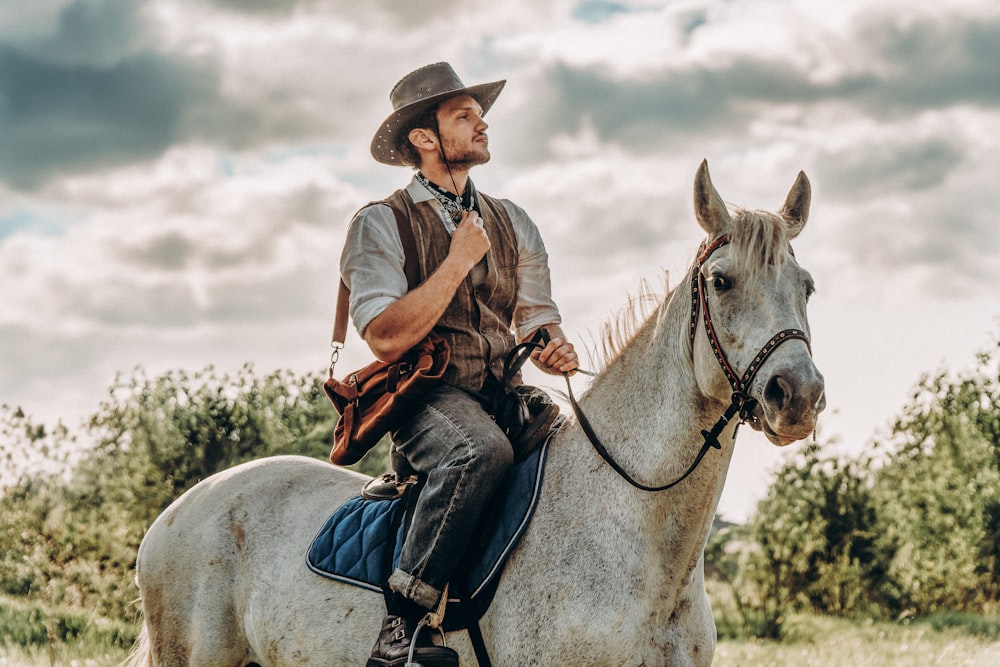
[0,367,337,617]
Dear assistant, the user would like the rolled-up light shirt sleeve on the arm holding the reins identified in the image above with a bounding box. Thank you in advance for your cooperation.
[502,199,562,340]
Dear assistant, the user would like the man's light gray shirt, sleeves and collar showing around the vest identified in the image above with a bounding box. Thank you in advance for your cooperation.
[340,178,562,340]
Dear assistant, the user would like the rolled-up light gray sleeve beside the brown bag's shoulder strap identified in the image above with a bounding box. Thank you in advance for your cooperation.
[340,204,407,336]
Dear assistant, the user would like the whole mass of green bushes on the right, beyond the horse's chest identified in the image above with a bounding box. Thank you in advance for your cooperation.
[730,334,1000,637]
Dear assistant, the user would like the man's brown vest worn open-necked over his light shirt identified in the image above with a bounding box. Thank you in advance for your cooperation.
[386,190,518,391]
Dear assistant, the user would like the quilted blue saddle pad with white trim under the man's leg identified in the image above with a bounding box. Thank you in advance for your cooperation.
[306,441,549,604]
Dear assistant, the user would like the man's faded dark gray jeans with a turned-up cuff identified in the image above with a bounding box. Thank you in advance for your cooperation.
[389,383,513,609]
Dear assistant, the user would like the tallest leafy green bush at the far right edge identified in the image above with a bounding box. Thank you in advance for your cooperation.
[873,351,1000,615]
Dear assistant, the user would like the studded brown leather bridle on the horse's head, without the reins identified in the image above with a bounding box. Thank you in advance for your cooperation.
[691,234,812,448]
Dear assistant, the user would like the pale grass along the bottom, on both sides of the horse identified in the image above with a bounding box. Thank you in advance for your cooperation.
[0,616,1000,667]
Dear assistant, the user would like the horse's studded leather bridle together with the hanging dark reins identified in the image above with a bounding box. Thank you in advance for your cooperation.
[528,234,812,493]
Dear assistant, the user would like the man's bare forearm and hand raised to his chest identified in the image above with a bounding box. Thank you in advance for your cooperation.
[364,211,490,362]
